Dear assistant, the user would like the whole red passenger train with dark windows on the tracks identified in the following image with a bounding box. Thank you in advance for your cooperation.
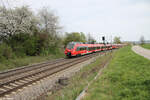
[65,42,121,57]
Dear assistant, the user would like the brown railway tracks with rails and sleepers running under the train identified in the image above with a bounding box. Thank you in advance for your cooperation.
[0,53,101,97]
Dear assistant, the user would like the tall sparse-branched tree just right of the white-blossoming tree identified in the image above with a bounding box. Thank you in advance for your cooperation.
[38,8,62,47]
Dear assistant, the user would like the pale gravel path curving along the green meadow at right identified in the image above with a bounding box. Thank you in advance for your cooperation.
[132,46,150,60]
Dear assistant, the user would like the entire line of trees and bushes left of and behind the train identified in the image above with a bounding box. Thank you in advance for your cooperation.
[0,6,94,61]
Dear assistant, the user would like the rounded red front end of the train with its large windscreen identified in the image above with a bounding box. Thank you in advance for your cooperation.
[65,42,75,57]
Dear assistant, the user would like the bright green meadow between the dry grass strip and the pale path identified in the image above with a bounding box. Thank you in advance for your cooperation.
[84,46,150,100]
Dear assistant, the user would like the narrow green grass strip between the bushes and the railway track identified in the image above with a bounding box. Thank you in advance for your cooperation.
[0,52,64,71]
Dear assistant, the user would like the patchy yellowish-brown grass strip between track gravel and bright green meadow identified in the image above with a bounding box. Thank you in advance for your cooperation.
[45,53,112,100]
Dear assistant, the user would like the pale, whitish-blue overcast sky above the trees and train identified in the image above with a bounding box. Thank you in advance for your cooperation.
[3,0,150,41]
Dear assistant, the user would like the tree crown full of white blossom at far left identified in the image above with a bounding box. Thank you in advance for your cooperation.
[0,6,38,39]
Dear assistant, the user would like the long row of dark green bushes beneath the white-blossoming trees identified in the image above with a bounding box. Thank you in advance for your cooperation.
[1,33,62,59]
